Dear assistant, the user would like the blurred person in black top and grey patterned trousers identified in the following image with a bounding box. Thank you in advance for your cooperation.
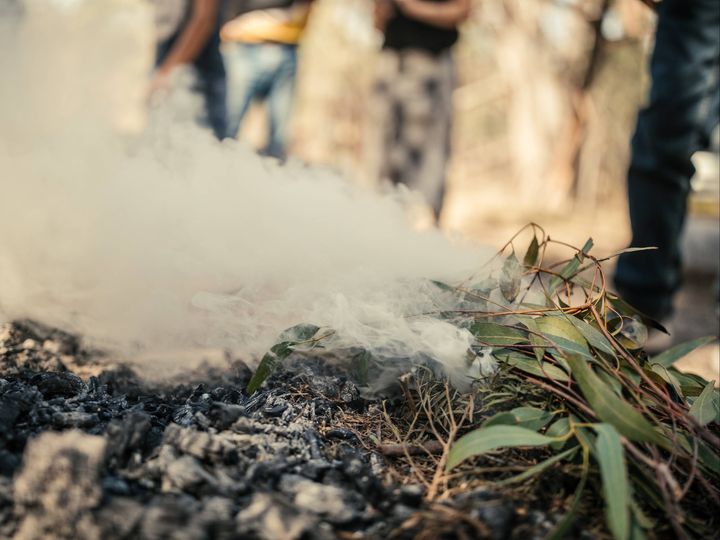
[370,0,471,220]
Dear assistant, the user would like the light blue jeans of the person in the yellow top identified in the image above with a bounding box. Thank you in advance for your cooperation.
[222,43,297,159]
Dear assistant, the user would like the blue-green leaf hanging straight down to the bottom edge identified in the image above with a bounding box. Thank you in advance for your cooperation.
[593,424,630,540]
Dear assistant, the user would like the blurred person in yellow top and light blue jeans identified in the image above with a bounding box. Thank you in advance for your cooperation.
[220,0,312,159]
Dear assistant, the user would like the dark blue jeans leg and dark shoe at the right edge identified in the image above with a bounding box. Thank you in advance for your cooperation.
[615,0,720,319]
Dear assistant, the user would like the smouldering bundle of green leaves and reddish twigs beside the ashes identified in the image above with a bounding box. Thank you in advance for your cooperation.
[249,224,720,539]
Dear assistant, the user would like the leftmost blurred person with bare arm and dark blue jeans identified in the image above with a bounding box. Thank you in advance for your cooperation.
[151,0,226,139]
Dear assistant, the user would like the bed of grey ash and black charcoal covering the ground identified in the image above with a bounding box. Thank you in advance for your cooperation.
[0,322,558,540]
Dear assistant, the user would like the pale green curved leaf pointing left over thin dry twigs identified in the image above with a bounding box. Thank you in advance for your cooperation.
[447,426,556,470]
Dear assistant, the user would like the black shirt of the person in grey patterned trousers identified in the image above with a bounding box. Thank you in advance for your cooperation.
[383,0,458,54]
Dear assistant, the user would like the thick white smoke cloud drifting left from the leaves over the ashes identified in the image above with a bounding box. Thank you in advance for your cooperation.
[0,0,488,382]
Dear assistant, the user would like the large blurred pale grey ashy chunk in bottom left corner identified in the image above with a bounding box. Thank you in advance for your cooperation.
[15,431,105,540]
